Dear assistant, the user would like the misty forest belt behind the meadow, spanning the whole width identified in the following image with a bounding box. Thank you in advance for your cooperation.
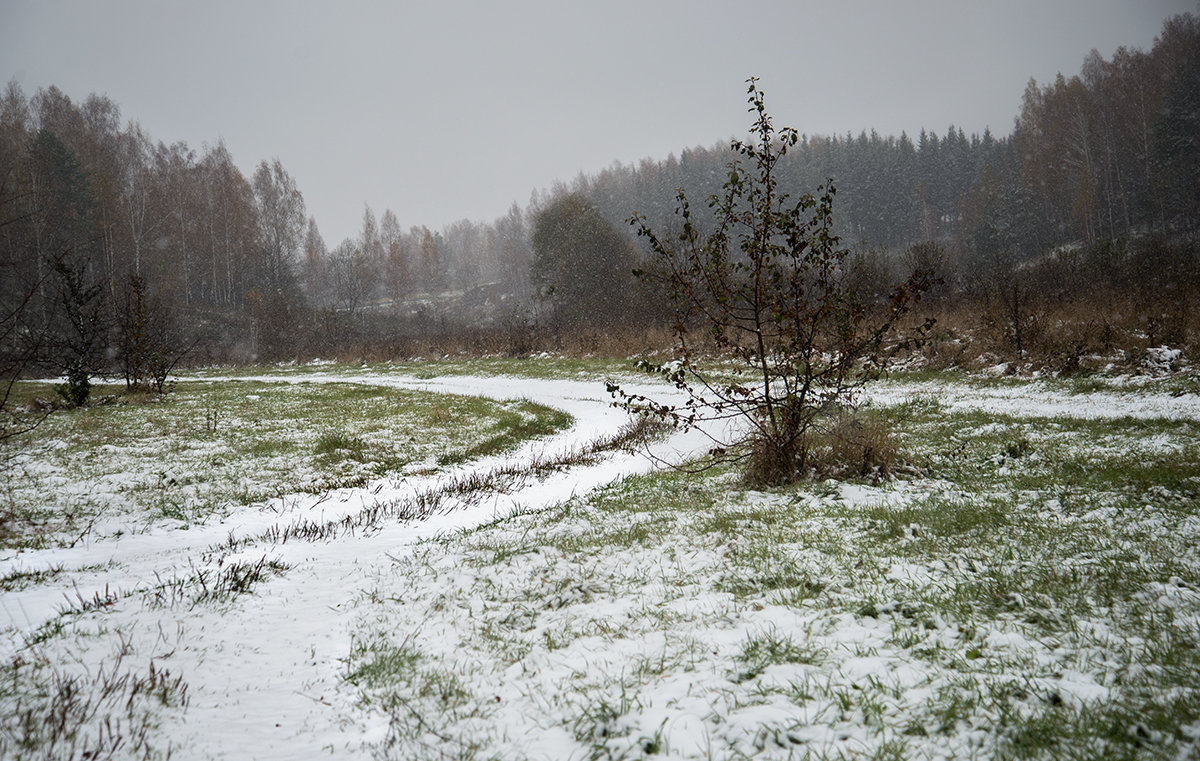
[0,14,1200,385]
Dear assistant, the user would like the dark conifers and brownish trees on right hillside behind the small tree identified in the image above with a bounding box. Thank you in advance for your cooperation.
[572,14,1200,257]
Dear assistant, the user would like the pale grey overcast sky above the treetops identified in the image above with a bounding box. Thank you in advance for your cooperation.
[0,0,1200,242]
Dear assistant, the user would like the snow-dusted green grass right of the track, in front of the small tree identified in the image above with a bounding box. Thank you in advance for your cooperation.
[352,387,1200,759]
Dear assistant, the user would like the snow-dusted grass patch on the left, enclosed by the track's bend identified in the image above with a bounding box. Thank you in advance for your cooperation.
[0,381,571,547]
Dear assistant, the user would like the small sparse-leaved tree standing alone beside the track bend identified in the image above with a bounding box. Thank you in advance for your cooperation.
[610,78,930,484]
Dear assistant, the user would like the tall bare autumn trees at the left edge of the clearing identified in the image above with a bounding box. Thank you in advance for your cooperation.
[0,84,305,383]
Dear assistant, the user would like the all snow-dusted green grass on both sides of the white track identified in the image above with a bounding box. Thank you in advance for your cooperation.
[0,360,1200,761]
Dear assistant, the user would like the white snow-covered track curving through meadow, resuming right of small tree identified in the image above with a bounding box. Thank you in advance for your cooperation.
[0,373,1200,759]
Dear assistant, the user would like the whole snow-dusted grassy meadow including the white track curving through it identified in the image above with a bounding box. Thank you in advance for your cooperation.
[0,360,1200,759]
